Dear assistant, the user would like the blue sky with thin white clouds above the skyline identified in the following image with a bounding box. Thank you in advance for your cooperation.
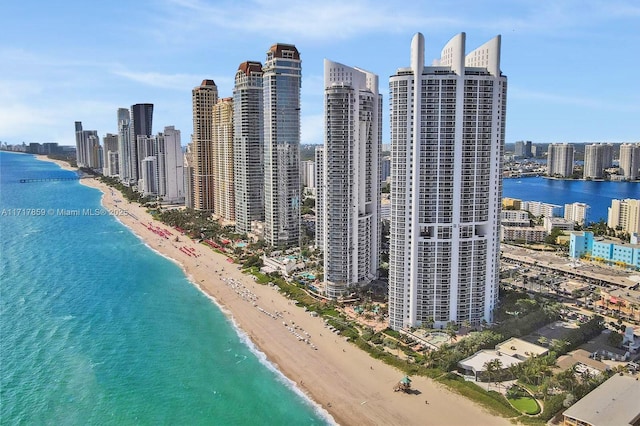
[0,0,640,145]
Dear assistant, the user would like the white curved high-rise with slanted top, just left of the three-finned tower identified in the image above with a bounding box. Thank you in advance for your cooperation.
[316,59,382,298]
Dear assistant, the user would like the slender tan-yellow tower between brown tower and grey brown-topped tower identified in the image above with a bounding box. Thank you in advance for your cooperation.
[212,98,236,221]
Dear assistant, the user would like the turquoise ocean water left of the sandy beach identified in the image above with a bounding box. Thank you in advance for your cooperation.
[0,152,332,425]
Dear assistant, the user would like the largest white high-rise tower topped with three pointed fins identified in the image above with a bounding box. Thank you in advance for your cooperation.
[389,33,507,330]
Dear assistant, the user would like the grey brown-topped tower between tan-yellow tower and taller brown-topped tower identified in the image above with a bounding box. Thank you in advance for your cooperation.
[233,61,264,234]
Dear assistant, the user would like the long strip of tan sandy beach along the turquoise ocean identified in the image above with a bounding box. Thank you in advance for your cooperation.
[36,156,511,425]
